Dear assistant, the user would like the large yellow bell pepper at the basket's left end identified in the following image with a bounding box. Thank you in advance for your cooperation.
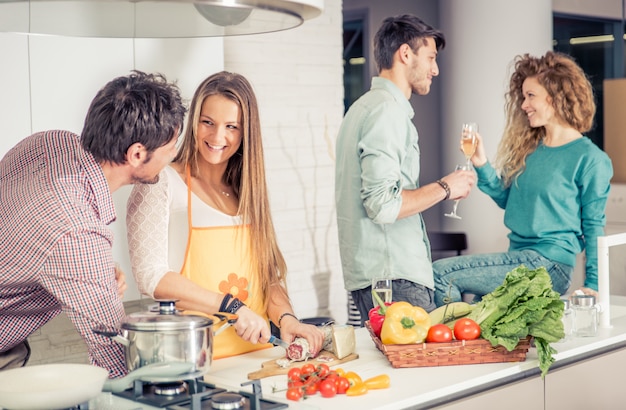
[380,301,430,345]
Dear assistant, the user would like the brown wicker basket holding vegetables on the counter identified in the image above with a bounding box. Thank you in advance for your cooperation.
[365,321,530,367]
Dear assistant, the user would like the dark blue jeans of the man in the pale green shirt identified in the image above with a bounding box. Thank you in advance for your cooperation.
[350,279,436,326]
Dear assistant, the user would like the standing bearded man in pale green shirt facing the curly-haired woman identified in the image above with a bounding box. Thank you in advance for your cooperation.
[335,15,476,323]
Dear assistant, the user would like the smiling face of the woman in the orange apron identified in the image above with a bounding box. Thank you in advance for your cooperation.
[196,94,243,165]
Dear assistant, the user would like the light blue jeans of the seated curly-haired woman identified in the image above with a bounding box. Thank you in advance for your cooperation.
[433,250,574,306]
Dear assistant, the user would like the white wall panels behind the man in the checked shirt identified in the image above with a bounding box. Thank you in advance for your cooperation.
[0,33,224,300]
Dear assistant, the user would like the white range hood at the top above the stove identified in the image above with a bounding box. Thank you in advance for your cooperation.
[0,0,323,38]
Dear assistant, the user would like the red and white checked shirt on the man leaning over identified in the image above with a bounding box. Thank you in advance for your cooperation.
[0,131,126,377]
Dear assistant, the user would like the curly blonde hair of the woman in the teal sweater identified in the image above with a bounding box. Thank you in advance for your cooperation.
[496,51,596,187]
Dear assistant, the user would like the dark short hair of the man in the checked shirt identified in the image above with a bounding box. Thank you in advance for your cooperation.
[81,71,186,164]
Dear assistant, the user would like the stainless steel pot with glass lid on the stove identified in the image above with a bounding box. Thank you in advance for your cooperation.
[94,300,237,374]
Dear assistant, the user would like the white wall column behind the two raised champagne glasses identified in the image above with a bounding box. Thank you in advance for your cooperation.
[439,0,552,253]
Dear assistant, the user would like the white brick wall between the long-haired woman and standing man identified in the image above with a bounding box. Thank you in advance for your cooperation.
[224,0,347,323]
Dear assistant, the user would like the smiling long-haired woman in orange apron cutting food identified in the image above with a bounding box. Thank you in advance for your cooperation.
[127,72,323,358]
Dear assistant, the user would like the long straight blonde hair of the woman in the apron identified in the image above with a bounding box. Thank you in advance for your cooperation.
[174,71,287,310]
